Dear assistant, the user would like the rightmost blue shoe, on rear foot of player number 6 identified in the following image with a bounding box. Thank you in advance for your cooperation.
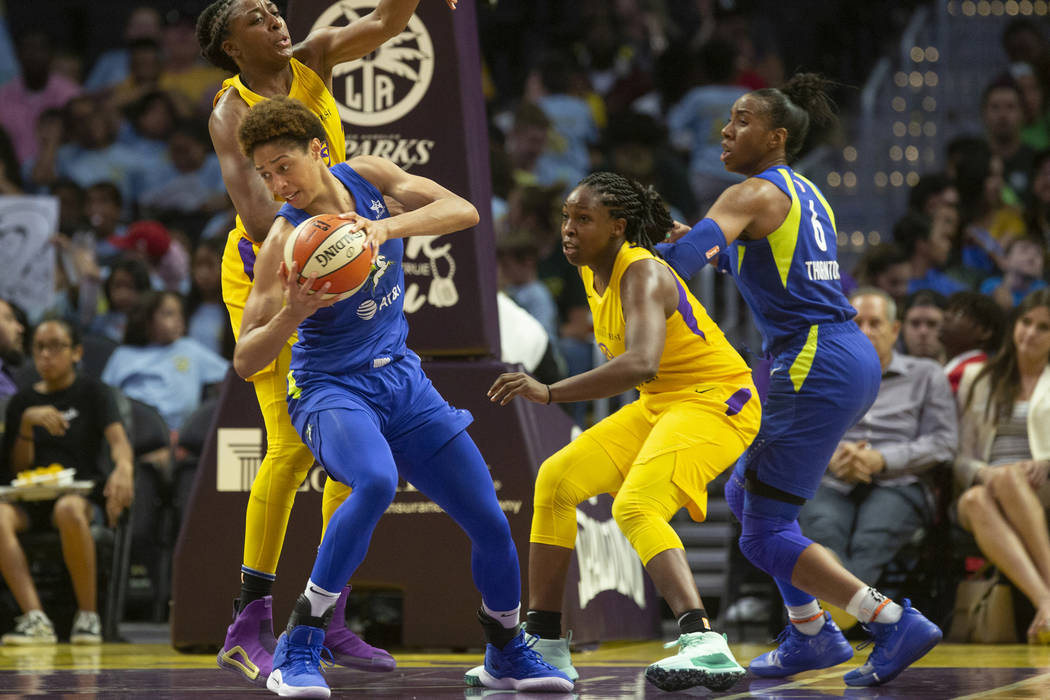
[843,598,943,685]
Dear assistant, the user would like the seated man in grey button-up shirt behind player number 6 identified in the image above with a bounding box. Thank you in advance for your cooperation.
[799,289,959,617]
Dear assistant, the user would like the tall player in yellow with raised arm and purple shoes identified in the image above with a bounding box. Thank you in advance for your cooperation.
[197,0,456,684]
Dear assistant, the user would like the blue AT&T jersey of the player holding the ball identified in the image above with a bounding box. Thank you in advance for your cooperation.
[277,163,408,377]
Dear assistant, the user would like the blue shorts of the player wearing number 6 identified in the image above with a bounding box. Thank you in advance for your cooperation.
[735,321,882,505]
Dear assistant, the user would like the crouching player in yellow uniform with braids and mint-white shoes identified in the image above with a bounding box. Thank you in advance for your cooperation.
[487,172,761,691]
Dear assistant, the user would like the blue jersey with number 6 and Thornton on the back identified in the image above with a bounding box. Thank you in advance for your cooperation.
[725,166,857,352]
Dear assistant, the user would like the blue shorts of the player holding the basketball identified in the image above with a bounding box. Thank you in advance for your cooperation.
[288,349,474,466]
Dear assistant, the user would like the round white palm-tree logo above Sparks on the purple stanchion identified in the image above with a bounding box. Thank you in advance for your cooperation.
[311,0,434,126]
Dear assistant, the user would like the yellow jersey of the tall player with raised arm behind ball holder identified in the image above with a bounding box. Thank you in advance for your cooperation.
[212,58,347,372]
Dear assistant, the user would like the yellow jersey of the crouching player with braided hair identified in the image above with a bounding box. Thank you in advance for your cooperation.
[580,242,751,397]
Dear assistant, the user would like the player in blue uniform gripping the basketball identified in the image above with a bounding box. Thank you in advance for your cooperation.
[233,98,572,698]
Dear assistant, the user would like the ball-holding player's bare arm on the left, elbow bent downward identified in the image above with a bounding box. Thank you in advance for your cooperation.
[233,217,338,379]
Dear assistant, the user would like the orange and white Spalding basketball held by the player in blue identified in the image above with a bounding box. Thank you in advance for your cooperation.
[285,214,372,299]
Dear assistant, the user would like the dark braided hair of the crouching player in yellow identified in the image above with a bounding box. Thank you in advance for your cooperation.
[578,170,674,253]
